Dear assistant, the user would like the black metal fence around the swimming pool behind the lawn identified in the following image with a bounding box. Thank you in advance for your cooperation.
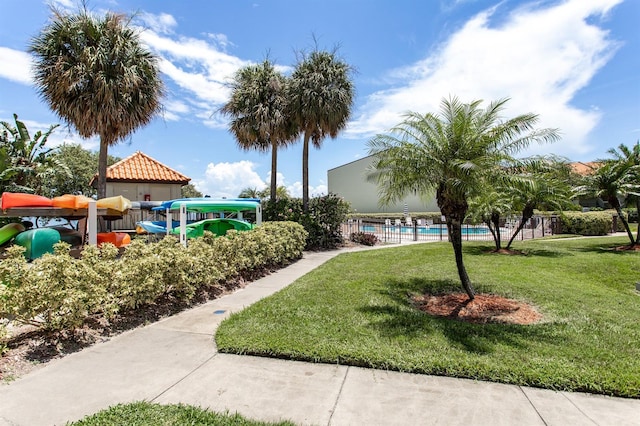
[342,216,560,244]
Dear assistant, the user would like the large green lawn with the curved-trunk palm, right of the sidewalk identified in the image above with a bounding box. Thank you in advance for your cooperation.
[216,237,640,398]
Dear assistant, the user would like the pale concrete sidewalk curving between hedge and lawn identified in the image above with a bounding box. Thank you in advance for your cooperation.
[0,250,640,426]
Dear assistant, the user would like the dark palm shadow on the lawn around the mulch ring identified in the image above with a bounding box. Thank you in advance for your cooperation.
[362,278,561,355]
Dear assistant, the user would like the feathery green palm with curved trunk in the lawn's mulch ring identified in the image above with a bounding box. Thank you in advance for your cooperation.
[369,97,558,299]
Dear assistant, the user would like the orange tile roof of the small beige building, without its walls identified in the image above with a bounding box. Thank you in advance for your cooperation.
[92,151,191,185]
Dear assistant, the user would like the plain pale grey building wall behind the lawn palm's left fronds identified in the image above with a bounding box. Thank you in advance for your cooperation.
[327,156,440,213]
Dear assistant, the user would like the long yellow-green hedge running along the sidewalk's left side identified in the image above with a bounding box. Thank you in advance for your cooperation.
[0,222,307,330]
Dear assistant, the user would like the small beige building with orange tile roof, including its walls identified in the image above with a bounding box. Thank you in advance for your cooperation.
[91,151,191,201]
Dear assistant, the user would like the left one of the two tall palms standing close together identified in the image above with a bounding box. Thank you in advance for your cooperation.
[221,60,298,201]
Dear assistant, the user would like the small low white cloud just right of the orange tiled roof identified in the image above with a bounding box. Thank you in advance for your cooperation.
[194,161,267,198]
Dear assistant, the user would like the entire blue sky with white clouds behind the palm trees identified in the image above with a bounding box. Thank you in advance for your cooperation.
[0,0,640,196]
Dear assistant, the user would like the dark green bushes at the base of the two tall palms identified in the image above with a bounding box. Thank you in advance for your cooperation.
[263,194,350,250]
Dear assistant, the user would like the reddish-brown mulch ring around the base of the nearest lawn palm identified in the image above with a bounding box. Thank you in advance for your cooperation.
[412,293,542,325]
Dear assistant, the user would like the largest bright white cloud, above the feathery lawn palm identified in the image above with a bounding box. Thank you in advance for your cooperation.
[346,0,621,159]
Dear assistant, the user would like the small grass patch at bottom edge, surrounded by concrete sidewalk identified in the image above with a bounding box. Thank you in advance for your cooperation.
[71,402,293,426]
